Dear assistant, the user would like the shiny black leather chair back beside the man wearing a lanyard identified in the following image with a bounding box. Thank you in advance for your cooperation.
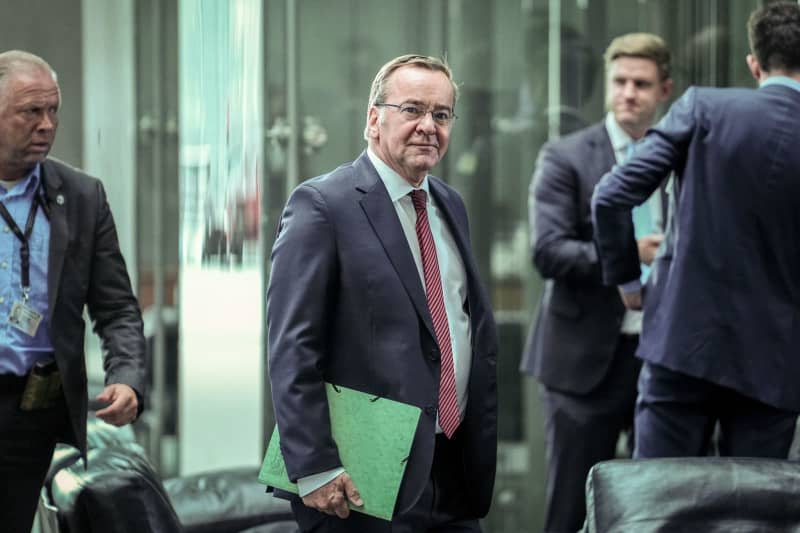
[51,443,182,533]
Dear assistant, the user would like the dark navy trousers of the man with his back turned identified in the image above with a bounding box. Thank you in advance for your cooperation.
[634,362,797,459]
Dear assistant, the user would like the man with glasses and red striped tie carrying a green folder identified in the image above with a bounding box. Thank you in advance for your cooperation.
[267,55,497,533]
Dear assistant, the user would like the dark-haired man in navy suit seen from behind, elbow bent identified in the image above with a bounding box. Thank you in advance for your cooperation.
[593,3,800,458]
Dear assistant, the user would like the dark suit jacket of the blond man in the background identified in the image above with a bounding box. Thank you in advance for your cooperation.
[521,122,625,394]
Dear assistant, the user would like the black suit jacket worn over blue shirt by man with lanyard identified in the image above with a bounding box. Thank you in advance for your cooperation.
[41,159,145,456]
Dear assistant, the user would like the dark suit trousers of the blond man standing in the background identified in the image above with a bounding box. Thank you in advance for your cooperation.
[540,335,641,533]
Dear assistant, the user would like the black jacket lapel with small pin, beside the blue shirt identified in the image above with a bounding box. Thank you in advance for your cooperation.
[42,160,69,322]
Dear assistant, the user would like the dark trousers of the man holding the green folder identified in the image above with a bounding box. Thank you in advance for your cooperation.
[292,430,481,533]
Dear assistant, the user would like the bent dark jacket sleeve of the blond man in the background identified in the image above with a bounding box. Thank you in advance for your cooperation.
[528,139,600,285]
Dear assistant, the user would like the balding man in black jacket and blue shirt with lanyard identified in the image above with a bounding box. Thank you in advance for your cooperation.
[0,51,144,533]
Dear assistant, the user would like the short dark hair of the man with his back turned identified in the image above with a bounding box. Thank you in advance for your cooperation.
[747,2,800,72]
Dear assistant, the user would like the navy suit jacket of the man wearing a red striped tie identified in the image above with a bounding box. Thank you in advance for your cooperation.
[267,153,497,522]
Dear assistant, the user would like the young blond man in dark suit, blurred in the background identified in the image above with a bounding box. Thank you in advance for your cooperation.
[521,33,672,533]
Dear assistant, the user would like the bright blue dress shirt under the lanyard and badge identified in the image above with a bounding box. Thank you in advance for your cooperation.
[0,164,53,376]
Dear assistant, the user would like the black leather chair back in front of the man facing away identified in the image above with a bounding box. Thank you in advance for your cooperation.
[584,457,800,533]
